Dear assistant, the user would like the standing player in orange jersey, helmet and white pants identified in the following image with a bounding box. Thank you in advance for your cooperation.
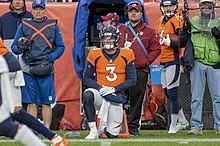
[157,0,189,133]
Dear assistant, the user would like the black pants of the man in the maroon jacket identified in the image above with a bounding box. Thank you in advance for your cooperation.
[127,70,148,133]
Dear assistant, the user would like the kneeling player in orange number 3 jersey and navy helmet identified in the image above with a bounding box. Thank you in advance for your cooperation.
[83,25,136,139]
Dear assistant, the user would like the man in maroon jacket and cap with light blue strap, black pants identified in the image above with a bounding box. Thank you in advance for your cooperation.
[119,2,161,135]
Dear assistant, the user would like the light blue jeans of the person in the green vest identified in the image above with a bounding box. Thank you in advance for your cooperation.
[190,61,220,130]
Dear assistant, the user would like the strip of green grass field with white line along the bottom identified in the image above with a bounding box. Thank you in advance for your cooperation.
[0,130,220,146]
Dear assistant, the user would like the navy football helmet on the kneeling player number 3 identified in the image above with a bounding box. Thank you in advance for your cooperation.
[99,25,120,49]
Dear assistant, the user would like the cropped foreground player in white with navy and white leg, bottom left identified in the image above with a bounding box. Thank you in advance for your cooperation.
[0,55,46,146]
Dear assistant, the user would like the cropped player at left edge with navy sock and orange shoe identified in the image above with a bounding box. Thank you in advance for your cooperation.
[0,38,68,146]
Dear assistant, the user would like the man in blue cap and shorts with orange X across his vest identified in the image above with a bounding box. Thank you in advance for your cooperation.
[11,0,65,128]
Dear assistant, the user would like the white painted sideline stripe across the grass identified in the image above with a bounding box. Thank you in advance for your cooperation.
[0,138,220,143]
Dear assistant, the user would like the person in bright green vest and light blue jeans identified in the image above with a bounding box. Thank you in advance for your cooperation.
[180,0,220,135]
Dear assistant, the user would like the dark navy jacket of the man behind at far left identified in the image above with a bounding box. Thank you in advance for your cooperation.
[0,0,33,40]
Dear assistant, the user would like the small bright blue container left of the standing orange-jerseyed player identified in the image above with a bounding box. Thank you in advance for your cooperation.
[150,65,163,85]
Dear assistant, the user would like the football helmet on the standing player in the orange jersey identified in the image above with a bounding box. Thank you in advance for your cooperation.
[160,0,178,17]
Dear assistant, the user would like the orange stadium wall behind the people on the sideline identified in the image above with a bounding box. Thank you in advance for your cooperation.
[0,2,199,129]
